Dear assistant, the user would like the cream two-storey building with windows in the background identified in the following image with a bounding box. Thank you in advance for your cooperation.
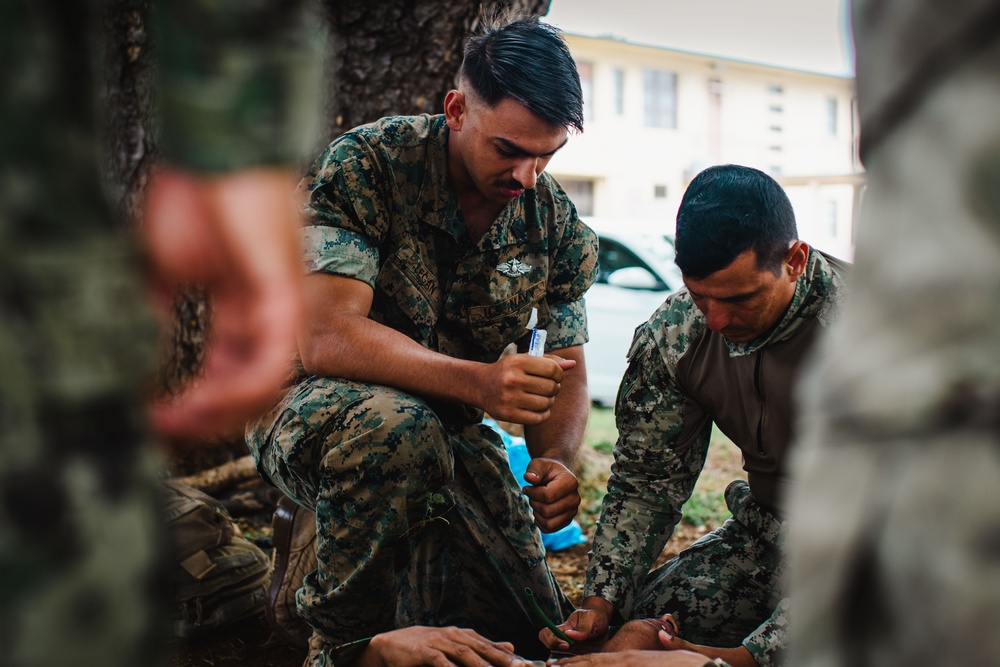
[548,32,864,259]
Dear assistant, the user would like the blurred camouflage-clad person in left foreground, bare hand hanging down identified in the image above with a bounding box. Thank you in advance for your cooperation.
[0,0,314,667]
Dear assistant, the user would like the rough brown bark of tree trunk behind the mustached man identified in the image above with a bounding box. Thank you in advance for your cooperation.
[101,0,551,402]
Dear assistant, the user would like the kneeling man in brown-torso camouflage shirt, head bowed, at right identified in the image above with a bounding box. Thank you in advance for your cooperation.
[542,165,845,667]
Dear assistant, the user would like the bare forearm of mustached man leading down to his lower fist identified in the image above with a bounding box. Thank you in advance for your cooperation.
[524,346,590,462]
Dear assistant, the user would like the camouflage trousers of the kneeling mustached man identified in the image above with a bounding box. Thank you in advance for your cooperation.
[249,378,569,665]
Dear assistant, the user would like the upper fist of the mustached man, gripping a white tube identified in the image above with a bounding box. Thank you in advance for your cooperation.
[476,354,576,425]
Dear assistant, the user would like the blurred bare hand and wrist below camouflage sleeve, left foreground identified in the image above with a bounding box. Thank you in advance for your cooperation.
[143,170,302,438]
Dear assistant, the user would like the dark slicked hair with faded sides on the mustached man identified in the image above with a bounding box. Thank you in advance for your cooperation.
[460,17,583,132]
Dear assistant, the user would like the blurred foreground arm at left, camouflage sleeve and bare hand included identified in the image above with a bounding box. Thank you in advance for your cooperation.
[142,0,322,439]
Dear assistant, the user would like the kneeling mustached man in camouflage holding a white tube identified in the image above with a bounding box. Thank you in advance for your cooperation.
[247,13,597,665]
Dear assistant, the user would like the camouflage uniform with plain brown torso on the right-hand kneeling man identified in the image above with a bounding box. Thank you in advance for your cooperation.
[584,249,846,665]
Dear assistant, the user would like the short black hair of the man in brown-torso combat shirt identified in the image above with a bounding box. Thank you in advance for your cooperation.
[674,164,798,280]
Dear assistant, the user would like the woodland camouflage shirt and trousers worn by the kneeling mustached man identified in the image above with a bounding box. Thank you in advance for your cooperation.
[247,116,597,665]
